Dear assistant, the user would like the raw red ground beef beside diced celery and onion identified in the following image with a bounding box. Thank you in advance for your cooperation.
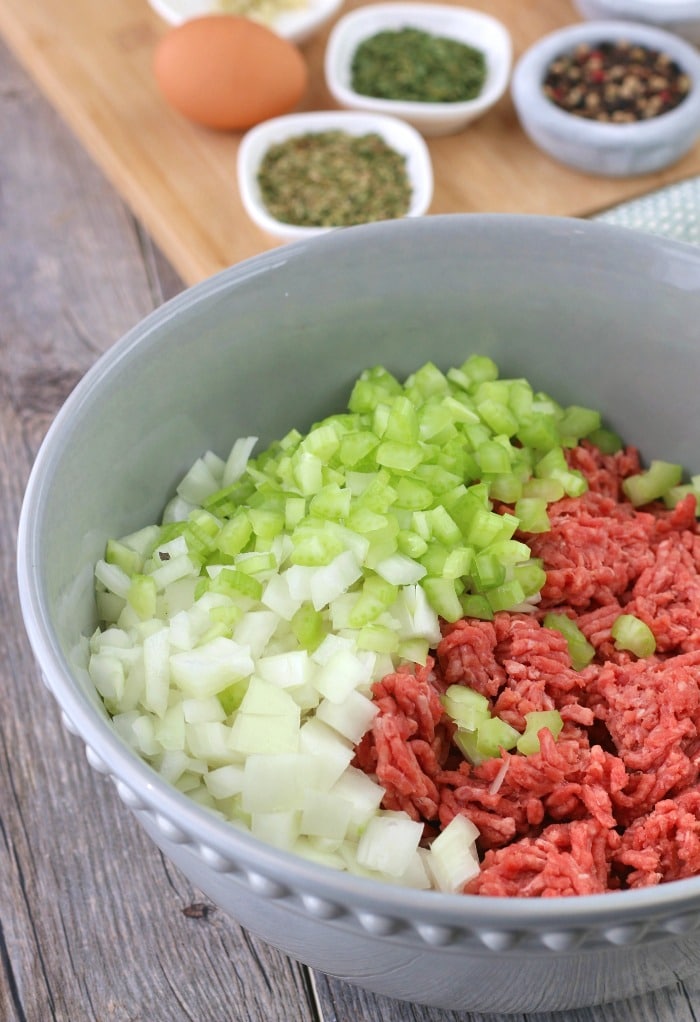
[356,444,700,897]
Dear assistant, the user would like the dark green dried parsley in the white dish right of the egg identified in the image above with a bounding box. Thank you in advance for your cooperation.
[351,28,486,103]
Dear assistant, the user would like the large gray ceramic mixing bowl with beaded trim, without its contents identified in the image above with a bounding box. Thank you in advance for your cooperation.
[18,216,700,1013]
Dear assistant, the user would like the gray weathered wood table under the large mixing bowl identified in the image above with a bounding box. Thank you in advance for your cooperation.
[0,33,700,1022]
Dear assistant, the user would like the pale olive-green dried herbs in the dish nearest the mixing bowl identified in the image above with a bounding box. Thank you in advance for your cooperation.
[258,130,412,227]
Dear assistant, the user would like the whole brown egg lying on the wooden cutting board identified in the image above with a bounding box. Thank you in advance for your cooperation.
[153,14,309,131]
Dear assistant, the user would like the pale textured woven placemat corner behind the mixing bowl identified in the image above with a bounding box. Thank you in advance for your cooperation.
[592,177,700,245]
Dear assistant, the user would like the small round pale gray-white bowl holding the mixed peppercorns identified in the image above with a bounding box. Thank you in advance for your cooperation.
[511,21,700,177]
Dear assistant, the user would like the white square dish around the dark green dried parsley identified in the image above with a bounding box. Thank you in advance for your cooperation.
[324,2,512,135]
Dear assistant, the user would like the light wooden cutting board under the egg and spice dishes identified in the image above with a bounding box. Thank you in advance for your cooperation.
[0,0,700,284]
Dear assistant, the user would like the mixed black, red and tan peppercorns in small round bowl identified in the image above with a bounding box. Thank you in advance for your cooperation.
[544,40,690,124]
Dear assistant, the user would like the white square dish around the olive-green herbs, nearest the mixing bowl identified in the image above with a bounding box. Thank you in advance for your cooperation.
[238,110,433,241]
